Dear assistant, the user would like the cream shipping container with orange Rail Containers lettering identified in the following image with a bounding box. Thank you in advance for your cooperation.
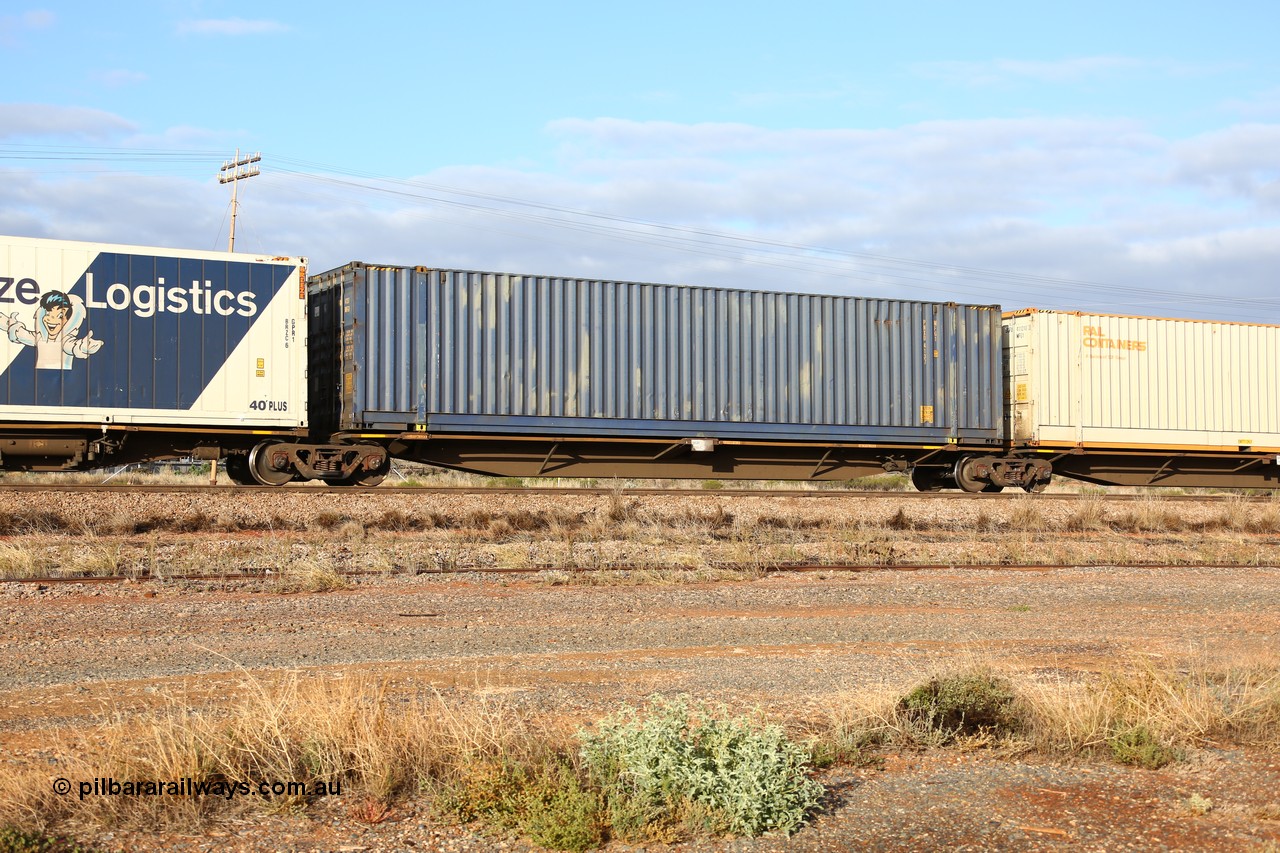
[1004,309,1280,452]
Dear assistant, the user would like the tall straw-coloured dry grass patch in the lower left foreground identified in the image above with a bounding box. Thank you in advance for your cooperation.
[0,674,545,830]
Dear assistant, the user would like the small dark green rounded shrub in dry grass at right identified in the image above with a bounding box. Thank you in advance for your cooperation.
[897,672,1019,743]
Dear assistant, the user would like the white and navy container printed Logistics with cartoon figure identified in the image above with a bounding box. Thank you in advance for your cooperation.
[0,237,307,428]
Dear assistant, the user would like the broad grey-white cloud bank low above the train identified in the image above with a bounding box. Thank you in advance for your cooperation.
[0,119,1280,321]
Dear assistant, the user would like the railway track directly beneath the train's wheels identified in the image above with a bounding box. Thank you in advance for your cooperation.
[0,483,1275,503]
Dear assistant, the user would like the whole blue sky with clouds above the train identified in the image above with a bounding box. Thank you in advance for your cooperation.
[0,0,1280,323]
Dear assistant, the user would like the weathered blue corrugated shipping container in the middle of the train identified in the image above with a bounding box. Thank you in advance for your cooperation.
[304,264,1002,442]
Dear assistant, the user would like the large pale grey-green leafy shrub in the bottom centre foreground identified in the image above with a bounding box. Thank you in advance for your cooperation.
[579,697,823,841]
